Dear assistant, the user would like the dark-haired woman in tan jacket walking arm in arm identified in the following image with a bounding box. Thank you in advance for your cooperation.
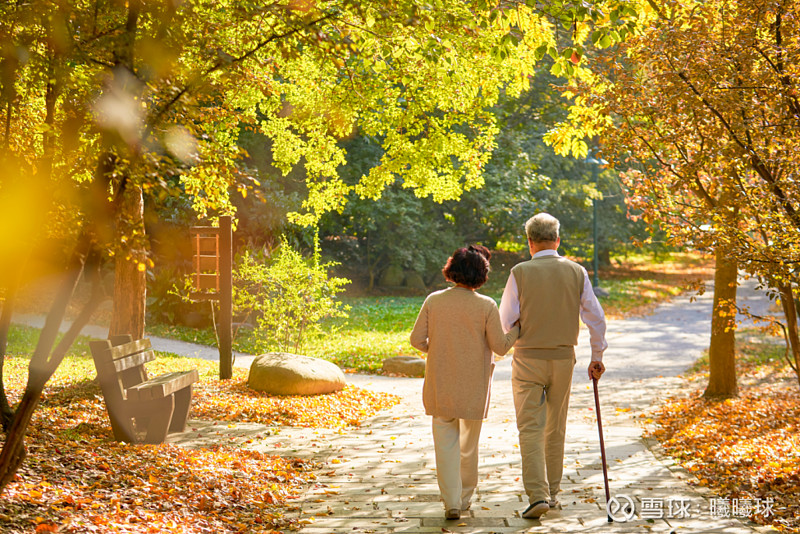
[411,245,519,519]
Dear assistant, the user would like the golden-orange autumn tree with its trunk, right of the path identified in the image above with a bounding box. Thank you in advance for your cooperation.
[550,0,800,396]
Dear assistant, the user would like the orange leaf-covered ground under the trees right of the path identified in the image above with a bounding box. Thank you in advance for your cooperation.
[650,333,800,533]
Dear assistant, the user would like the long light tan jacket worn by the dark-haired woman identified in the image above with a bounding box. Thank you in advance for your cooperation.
[410,287,519,420]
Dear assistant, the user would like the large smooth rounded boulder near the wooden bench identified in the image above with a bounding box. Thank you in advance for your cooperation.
[247,352,345,395]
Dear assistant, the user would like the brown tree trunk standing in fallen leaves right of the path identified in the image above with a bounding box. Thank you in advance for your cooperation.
[703,248,739,398]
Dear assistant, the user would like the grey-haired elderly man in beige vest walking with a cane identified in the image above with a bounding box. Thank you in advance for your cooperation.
[500,213,608,519]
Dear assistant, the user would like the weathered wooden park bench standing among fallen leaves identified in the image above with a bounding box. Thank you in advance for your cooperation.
[90,336,199,443]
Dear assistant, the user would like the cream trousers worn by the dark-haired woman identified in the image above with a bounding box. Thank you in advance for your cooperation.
[433,417,483,510]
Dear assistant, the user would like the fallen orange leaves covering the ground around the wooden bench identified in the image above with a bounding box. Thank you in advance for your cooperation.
[0,327,396,533]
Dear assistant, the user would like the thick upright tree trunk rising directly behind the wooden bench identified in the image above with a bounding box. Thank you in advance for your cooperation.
[108,183,147,340]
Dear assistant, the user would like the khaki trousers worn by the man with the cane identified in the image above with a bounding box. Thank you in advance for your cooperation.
[511,356,575,504]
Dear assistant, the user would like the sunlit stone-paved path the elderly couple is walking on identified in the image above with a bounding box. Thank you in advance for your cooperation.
[14,280,780,534]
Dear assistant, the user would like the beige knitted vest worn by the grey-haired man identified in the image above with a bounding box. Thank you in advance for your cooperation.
[511,256,586,360]
